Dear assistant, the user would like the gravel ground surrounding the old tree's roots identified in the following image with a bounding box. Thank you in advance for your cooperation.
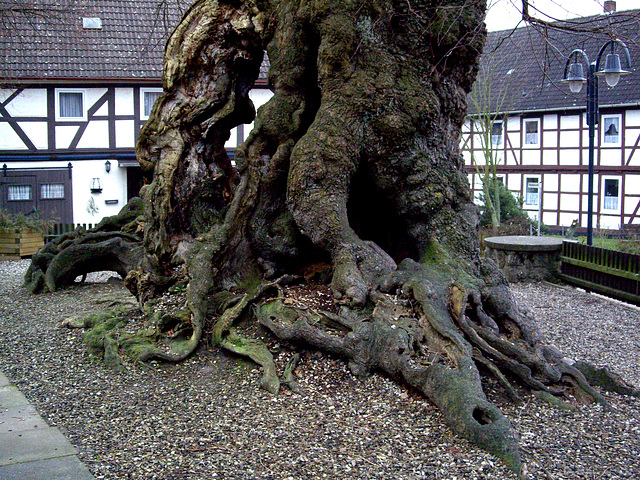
[0,260,640,480]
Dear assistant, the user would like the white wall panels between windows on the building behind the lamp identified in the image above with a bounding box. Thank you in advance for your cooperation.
[461,108,640,229]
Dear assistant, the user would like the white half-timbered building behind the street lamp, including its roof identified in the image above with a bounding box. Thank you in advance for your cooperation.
[463,6,640,230]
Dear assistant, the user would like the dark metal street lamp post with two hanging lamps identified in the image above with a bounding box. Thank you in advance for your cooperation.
[561,40,631,245]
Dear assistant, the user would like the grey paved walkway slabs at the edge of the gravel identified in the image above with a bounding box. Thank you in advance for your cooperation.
[0,372,94,480]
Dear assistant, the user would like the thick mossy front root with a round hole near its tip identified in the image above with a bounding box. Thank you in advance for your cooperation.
[255,268,520,471]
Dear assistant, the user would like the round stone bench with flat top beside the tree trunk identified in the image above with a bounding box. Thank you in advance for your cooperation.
[484,236,562,282]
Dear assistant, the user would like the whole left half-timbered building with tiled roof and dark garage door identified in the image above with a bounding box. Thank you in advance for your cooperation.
[0,0,271,224]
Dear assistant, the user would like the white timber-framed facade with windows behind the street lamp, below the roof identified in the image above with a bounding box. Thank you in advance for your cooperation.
[462,107,640,230]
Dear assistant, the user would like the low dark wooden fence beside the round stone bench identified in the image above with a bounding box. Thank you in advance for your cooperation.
[560,241,640,305]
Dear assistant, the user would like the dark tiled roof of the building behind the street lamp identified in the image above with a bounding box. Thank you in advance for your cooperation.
[470,10,640,113]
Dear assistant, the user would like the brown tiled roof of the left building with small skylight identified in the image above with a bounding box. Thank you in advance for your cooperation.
[0,0,188,81]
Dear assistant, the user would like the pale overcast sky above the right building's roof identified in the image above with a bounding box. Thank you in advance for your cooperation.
[487,0,640,31]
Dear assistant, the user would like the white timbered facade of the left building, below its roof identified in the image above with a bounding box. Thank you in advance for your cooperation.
[0,85,272,224]
